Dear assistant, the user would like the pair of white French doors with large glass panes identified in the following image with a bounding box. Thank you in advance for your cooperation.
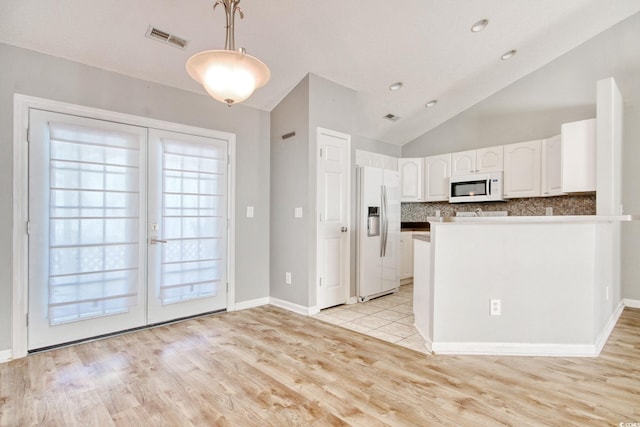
[28,109,228,350]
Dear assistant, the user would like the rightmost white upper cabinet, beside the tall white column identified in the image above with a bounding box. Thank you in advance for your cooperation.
[560,119,596,193]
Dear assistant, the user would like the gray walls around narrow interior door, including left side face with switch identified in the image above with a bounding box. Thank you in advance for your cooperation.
[270,74,400,307]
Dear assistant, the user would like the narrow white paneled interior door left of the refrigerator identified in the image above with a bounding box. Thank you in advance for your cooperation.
[317,129,351,309]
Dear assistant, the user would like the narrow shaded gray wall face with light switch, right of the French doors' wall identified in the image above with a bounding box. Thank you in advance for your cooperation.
[270,76,310,307]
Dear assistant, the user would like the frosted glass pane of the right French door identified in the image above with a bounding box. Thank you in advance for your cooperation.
[160,139,227,305]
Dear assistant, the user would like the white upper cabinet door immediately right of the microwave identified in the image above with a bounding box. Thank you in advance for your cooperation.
[504,140,542,199]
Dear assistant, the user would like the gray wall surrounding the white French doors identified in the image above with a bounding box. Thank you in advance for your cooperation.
[0,44,270,350]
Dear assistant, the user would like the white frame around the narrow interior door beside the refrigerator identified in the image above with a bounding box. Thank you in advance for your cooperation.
[310,127,352,315]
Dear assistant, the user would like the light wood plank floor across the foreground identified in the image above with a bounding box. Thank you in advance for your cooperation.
[0,306,640,427]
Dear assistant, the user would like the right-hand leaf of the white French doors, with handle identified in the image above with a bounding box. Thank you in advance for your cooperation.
[148,129,227,323]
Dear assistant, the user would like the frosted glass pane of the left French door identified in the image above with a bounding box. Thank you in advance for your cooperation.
[48,122,140,325]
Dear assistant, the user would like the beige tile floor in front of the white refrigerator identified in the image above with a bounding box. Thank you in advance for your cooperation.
[315,284,427,353]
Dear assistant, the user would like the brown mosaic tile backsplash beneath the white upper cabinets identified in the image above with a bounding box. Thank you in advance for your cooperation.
[402,194,596,222]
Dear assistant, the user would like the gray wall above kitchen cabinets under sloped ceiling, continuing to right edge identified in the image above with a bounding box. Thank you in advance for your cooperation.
[402,14,640,300]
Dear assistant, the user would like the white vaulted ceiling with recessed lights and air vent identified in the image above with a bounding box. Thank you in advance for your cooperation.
[0,0,640,145]
